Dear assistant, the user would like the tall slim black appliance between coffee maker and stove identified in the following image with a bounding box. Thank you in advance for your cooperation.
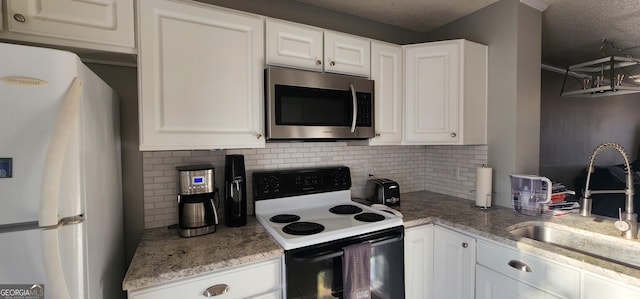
[224,155,247,227]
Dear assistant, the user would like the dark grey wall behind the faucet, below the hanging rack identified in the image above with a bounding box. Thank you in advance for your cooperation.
[540,71,640,192]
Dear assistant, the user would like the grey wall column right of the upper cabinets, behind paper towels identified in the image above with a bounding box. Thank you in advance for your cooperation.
[428,0,542,206]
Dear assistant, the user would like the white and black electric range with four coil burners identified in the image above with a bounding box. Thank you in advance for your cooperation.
[253,167,404,299]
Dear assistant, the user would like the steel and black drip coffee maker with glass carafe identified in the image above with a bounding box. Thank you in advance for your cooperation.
[176,164,218,237]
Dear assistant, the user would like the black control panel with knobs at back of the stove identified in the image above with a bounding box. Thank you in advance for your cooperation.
[253,166,351,200]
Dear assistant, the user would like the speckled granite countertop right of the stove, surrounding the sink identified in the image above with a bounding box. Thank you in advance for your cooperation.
[394,191,640,286]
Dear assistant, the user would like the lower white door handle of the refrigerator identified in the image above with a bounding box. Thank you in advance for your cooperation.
[40,226,71,299]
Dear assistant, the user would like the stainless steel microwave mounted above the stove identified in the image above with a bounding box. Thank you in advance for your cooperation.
[265,67,375,140]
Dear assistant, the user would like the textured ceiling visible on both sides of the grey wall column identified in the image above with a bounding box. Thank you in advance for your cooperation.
[296,0,640,68]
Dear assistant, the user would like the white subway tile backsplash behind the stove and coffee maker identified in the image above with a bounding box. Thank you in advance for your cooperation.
[143,142,487,228]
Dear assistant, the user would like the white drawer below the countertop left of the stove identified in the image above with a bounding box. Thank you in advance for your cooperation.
[129,259,281,299]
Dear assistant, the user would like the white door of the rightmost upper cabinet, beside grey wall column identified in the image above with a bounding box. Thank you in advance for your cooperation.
[404,42,460,144]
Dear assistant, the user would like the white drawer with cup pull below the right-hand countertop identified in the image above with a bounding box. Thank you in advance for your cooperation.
[477,240,580,298]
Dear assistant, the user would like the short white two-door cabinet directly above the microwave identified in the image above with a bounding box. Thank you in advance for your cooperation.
[266,19,371,78]
